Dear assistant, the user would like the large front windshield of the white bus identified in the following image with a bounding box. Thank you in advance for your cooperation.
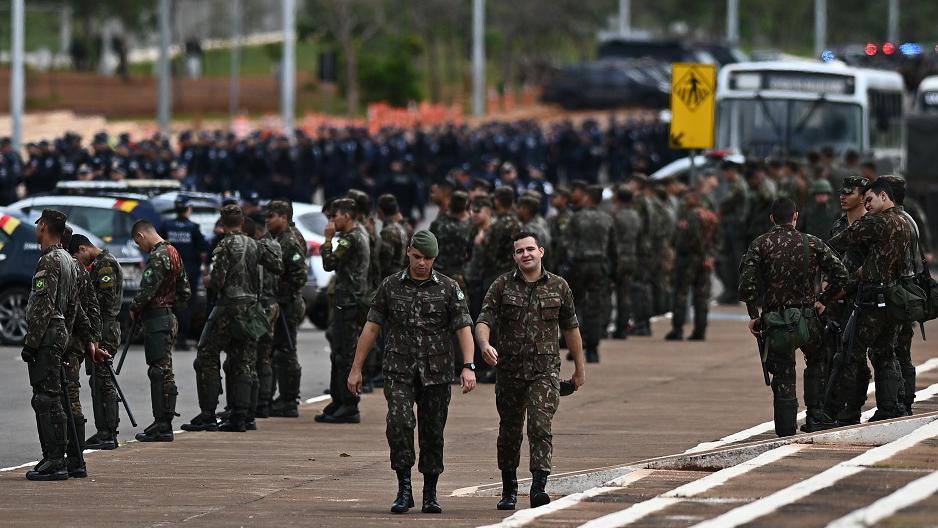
[717,98,863,156]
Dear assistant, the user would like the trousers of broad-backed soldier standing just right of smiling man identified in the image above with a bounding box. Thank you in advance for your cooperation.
[570,261,612,350]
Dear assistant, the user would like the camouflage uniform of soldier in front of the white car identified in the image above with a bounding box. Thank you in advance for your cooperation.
[322,223,371,409]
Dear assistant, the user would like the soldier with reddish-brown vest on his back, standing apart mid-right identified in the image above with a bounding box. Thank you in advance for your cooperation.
[665,191,719,341]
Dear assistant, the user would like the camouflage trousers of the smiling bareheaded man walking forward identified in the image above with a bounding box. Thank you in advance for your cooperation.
[495,375,560,473]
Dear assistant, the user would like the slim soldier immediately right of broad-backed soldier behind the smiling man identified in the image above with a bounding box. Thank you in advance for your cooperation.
[612,185,642,339]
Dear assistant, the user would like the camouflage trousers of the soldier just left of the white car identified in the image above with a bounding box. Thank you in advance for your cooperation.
[271,295,306,404]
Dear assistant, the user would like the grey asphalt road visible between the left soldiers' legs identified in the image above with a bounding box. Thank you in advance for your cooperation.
[0,322,329,467]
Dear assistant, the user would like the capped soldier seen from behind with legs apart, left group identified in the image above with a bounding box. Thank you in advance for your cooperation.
[182,205,258,432]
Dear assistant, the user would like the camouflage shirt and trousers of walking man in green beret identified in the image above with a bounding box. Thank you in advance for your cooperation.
[368,270,472,475]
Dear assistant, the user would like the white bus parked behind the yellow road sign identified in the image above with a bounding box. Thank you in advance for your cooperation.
[716,61,904,162]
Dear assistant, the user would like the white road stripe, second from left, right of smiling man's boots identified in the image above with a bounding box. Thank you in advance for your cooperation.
[582,444,807,528]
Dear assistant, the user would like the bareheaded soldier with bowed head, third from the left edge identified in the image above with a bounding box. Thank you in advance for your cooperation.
[69,234,124,450]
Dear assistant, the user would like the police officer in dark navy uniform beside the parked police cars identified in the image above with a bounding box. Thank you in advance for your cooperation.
[160,195,211,350]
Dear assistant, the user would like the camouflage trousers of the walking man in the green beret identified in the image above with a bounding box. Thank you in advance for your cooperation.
[384,378,451,475]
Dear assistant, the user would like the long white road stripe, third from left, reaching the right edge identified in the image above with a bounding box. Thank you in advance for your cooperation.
[694,421,938,528]
